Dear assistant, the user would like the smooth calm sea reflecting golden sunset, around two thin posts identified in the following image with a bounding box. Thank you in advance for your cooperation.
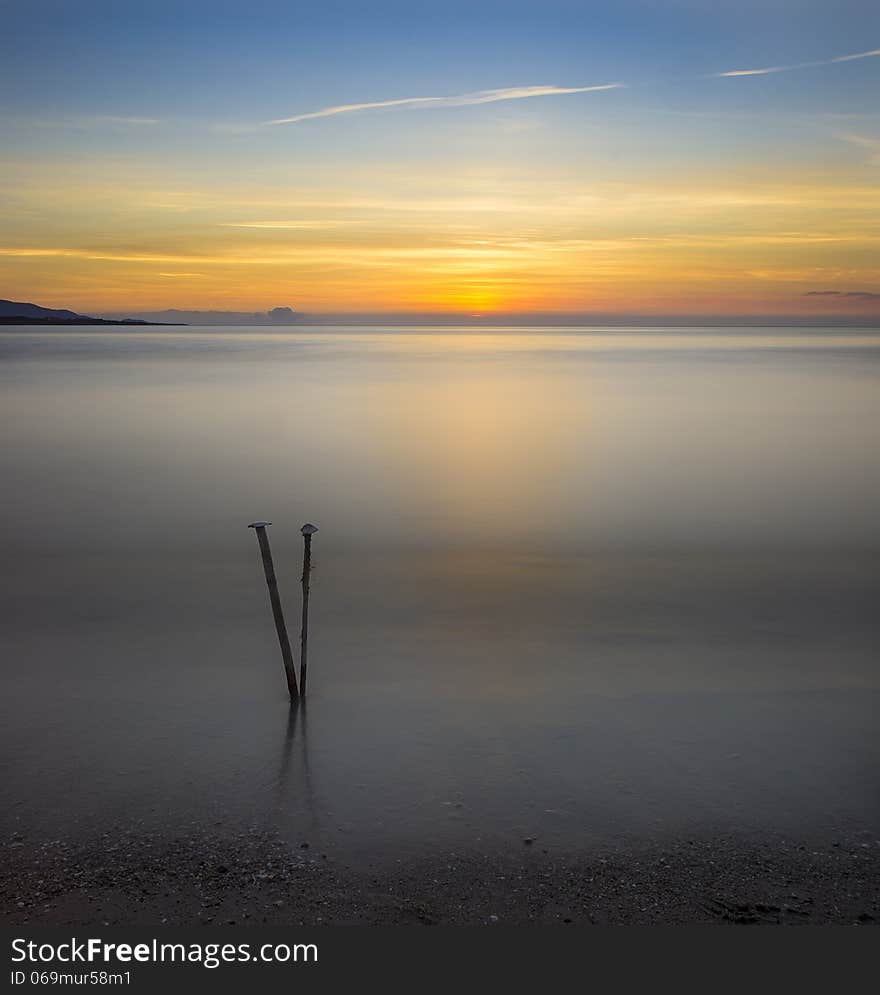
[0,328,880,855]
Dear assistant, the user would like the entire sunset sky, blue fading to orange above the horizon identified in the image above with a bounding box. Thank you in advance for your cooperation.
[0,0,880,316]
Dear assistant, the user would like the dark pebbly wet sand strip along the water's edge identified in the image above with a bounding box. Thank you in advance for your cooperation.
[0,832,880,926]
